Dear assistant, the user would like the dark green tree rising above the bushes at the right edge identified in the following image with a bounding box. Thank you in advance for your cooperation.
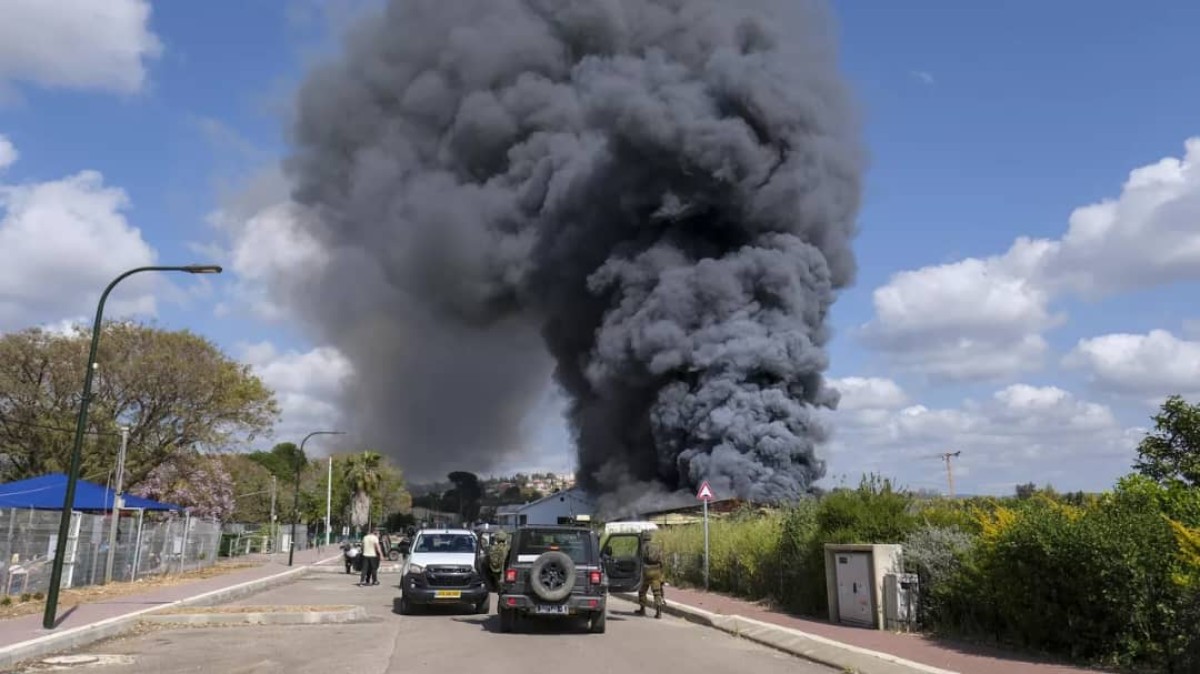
[1134,396,1200,487]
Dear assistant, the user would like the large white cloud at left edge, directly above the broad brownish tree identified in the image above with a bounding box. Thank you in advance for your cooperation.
[0,144,157,330]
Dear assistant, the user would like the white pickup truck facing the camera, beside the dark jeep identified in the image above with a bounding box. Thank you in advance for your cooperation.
[400,529,491,615]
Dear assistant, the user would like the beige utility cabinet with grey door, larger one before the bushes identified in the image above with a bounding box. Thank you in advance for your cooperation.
[824,543,904,630]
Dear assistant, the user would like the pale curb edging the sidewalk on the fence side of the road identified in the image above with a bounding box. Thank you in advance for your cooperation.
[0,554,343,670]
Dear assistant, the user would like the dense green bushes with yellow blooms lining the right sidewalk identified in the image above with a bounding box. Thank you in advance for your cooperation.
[664,476,1200,672]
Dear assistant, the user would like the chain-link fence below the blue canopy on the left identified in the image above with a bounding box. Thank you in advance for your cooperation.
[0,508,221,595]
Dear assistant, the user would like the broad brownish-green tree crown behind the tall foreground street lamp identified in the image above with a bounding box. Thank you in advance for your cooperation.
[0,321,278,488]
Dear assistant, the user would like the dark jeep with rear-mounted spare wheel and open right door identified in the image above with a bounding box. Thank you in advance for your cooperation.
[498,525,642,634]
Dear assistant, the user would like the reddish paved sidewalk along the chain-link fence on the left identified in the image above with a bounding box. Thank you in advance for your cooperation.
[0,547,338,649]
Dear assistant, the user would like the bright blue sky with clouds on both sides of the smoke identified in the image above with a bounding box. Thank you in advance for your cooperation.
[0,0,1200,492]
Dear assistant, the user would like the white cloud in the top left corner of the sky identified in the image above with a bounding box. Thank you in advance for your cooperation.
[0,0,162,94]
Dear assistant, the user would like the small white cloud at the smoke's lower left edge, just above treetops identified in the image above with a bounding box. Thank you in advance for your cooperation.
[240,342,354,450]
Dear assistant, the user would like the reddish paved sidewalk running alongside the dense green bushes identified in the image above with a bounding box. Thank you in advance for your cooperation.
[666,586,1096,674]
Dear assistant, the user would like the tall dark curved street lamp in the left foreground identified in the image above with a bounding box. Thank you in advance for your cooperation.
[42,265,222,630]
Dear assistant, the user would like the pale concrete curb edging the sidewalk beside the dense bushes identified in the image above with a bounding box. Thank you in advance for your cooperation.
[612,592,961,674]
